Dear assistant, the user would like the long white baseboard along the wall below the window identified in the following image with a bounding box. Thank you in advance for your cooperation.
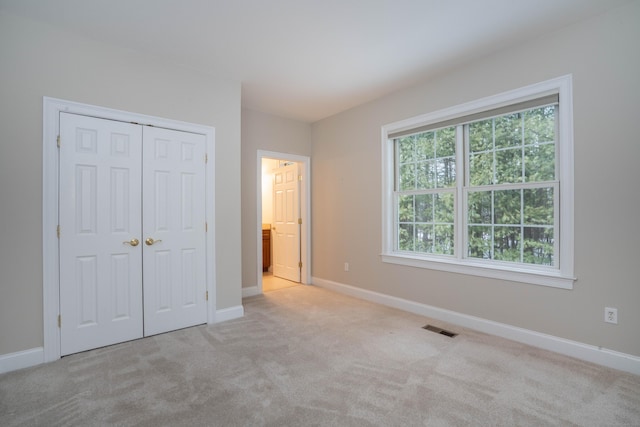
[312,277,640,375]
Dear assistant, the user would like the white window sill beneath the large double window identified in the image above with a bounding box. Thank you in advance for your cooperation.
[381,253,576,289]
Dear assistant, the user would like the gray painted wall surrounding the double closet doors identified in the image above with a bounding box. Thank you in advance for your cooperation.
[0,13,241,355]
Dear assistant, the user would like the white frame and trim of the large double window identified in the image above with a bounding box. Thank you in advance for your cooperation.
[381,74,576,289]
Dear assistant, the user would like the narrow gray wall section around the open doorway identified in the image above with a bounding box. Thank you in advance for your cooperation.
[242,108,311,287]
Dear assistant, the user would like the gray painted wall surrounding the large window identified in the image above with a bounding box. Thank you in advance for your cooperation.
[312,2,640,356]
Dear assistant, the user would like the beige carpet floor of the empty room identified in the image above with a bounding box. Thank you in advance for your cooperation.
[0,286,640,427]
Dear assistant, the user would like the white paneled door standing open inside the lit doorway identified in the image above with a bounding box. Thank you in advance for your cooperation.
[273,163,300,282]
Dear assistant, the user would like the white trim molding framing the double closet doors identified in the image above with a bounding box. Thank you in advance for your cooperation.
[42,96,219,362]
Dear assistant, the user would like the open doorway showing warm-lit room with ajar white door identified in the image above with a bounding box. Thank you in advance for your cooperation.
[257,151,311,293]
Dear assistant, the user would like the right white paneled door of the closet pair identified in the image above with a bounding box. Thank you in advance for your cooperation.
[142,127,207,336]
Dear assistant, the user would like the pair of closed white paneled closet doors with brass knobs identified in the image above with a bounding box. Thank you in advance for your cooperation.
[59,113,206,355]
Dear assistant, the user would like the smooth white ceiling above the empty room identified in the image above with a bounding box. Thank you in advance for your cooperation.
[0,0,629,122]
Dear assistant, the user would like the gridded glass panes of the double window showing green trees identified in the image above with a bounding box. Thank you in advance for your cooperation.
[395,100,558,266]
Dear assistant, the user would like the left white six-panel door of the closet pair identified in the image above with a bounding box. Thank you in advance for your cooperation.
[59,113,143,355]
